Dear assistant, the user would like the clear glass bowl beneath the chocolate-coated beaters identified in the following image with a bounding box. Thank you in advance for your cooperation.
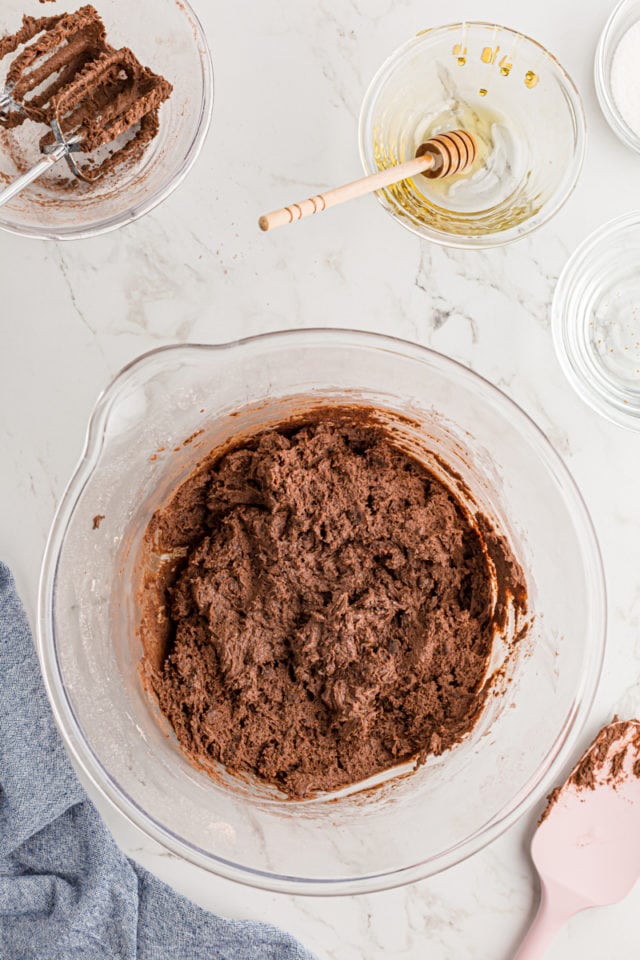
[0,0,213,240]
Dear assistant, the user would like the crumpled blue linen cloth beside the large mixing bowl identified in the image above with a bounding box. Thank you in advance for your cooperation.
[0,563,313,960]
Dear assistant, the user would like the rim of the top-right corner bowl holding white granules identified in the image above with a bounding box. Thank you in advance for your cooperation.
[594,0,640,153]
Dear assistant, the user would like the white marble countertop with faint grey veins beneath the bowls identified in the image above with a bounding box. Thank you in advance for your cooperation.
[0,0,640,960]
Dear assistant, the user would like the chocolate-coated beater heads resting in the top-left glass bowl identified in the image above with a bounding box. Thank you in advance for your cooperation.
[0,5,172,182]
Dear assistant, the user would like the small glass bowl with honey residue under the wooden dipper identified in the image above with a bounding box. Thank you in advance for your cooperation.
[360,23,585,247]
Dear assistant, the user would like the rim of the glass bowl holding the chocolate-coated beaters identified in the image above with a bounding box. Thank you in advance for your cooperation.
[0,0,214,240]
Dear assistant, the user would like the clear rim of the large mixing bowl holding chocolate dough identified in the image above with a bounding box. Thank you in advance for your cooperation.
[36,327,606,896]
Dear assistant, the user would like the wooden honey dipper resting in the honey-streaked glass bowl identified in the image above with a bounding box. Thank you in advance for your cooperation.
[258,130,478,231]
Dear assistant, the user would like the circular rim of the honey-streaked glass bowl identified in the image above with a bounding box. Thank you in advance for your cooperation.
[358,20,587,250]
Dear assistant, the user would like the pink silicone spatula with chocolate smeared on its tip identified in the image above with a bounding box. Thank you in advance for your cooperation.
[514,719,640,960]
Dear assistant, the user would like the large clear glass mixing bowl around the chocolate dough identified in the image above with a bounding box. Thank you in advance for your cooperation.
[37,329,605,894]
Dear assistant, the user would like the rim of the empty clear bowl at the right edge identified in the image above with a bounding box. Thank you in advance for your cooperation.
[551,210,640,430]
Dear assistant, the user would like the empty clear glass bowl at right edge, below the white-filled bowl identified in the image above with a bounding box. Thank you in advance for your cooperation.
[552,210,640,430]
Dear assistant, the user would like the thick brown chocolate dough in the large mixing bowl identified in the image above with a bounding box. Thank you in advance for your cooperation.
[141,407,526,799]
